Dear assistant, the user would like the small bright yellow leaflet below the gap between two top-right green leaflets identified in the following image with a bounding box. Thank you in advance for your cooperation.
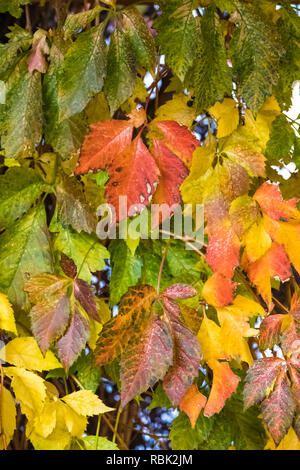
[208,98,240,139]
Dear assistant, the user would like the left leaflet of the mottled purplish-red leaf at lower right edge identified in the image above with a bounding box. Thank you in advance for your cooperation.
[244,357,285,409]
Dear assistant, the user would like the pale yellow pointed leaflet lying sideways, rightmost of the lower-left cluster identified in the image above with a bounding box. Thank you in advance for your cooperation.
[62,390,114,416]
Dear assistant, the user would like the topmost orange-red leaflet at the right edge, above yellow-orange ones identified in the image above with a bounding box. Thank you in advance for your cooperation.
[253,181,300,220]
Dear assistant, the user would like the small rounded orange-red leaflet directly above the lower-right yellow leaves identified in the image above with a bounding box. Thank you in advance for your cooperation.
[202,273,237,307]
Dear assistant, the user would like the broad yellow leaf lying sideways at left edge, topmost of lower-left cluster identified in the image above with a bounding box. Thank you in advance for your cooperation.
[0,336,62,372]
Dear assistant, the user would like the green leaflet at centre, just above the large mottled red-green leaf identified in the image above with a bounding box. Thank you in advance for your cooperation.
[109,240,142,305]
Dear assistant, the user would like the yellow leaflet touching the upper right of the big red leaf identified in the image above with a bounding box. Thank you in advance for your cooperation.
[154,93,197,127]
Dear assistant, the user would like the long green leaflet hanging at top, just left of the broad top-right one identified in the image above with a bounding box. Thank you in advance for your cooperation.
[188,4,232,111]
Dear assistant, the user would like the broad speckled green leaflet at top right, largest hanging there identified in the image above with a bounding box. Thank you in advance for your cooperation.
[229,2,284,115]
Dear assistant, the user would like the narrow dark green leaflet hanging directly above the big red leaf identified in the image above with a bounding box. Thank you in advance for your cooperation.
[104,26,136,115]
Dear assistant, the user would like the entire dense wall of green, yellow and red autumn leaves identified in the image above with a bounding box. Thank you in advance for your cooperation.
[0,0,300,450]
